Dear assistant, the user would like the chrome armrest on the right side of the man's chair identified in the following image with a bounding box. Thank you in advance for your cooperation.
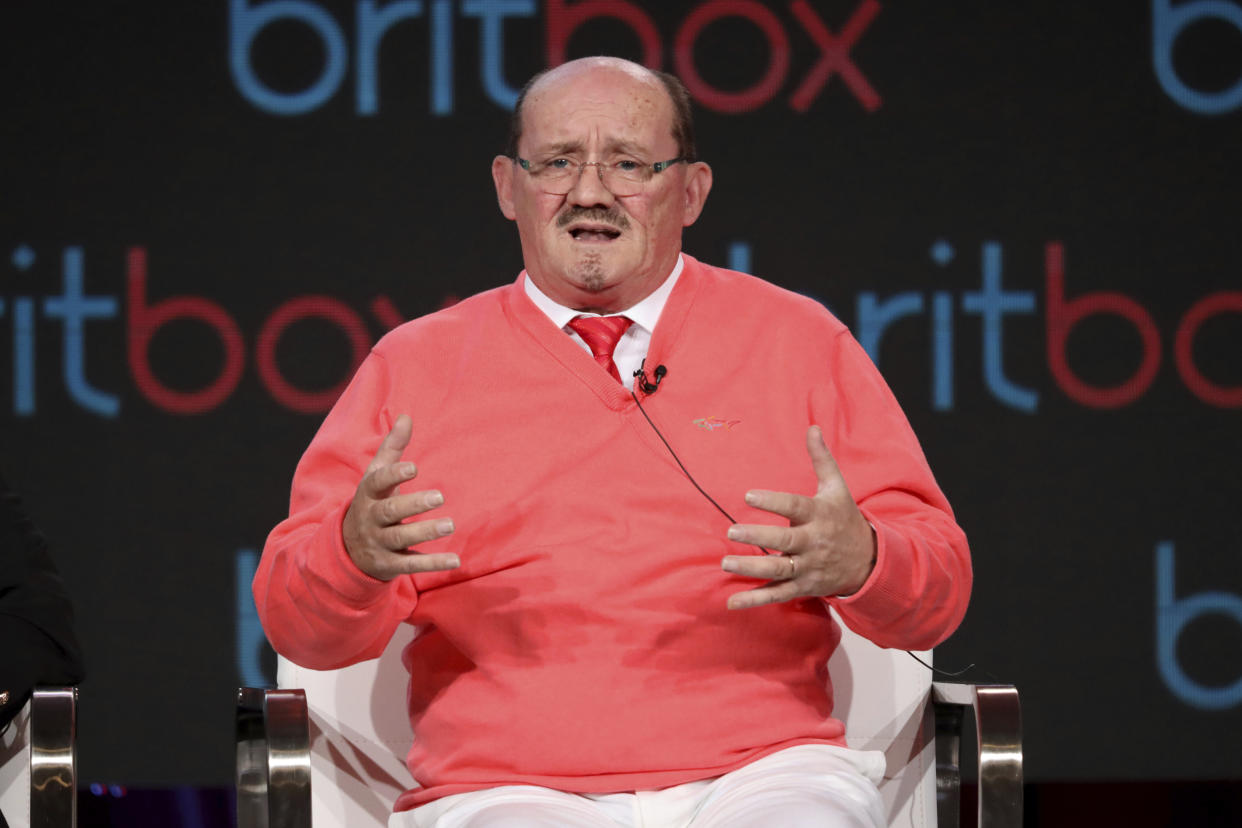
[932,682,1022,828]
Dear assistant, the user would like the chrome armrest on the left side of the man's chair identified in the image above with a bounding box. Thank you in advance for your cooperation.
[236,688,311,828]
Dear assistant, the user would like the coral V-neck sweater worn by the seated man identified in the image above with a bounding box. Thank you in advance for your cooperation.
[255,256,971,809]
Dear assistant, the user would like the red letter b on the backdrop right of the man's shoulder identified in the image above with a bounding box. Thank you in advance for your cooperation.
[1045,242,1160,408]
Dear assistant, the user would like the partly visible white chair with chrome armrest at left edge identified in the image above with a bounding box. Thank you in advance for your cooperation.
[0,688,77,828]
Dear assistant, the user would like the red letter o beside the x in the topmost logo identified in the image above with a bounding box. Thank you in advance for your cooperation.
[673,0,789,113]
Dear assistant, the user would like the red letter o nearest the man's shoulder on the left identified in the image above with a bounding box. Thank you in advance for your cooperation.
[255,295,371,413]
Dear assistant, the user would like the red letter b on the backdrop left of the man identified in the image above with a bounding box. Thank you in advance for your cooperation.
[127,247,246,415]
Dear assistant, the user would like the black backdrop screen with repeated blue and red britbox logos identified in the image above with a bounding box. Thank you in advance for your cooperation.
[0,0,1242,785]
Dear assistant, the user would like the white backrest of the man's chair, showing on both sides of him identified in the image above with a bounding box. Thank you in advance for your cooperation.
[277,624,935,828]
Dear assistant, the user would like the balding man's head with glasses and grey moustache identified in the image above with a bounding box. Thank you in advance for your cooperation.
[492,57,712,313]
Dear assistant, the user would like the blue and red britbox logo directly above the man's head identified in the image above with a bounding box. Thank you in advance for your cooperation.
[229,0,882,115]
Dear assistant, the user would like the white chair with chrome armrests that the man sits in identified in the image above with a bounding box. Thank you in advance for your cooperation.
[237,626,1022,828]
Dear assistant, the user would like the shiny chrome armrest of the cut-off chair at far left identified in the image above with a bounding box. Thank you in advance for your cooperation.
[30,686,77,828]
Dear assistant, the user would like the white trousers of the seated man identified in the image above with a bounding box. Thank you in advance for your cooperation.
[389,745,886,828]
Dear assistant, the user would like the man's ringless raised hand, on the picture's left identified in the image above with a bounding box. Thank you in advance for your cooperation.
[340,415,461,581]
